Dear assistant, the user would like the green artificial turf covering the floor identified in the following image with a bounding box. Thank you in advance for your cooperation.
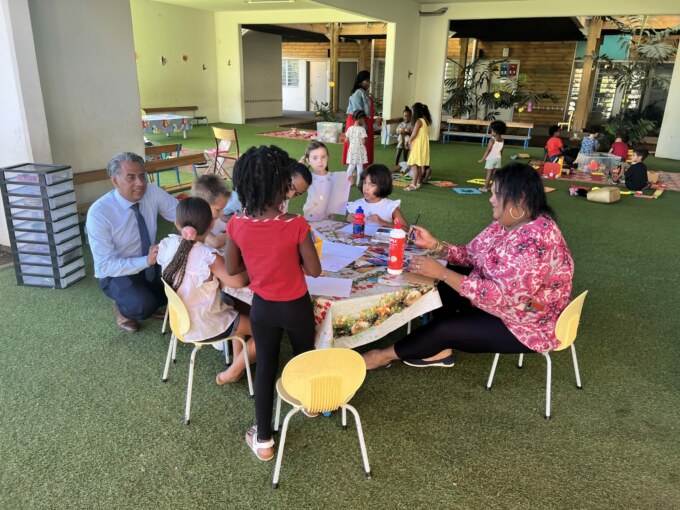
[0,126,680,509]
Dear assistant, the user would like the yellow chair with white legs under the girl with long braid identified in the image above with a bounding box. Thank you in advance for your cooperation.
[162,281,255,425]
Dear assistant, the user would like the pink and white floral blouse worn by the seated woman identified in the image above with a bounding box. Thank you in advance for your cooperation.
[447,216,574,352]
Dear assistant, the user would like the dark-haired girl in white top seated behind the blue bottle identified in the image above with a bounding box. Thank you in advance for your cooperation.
[347,165,409,230]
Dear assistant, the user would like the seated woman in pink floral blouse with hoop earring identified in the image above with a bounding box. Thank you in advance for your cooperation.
[364,163,574,369]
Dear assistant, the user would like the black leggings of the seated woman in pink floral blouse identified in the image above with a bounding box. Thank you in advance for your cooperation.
[394,266,534,359]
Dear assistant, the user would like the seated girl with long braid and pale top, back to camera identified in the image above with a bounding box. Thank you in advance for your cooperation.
[157,197,255,384]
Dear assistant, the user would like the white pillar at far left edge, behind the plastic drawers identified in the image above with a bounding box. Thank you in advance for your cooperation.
[0,0,52,246]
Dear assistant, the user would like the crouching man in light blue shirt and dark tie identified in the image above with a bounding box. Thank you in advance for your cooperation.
[86,152,178,333]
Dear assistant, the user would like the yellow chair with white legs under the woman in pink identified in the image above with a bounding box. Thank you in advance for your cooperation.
[486,291,588,420]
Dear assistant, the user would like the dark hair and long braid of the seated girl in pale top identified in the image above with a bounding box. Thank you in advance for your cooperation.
[163,197,212,292]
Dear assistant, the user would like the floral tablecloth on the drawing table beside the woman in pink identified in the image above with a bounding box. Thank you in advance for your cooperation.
[228,221,442,348]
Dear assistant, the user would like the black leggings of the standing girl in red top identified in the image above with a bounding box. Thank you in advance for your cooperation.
[250,293,315,442]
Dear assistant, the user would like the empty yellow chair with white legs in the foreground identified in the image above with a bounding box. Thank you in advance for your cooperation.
[272,348,371,489]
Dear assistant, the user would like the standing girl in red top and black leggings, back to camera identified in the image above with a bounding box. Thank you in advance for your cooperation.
[224,146,321,460]
